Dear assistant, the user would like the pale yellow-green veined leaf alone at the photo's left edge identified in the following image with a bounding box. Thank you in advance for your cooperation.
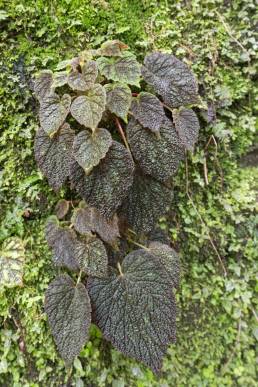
[0,237,25,288]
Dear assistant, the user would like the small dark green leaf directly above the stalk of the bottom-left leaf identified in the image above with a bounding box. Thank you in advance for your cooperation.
[75,237,108,277]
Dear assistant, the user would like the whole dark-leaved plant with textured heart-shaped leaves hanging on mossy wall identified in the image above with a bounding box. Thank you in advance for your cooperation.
[34,40,200,373]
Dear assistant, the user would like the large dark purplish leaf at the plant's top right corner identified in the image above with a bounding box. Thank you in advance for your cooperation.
[142,51,200,107]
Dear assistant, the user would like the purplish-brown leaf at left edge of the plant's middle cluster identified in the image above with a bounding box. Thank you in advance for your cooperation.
[45,217,79,271]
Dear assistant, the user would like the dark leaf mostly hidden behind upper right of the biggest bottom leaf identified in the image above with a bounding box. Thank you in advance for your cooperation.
[149,242,180,288]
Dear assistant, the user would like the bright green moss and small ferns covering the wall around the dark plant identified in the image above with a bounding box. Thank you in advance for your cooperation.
[0,0,258,387]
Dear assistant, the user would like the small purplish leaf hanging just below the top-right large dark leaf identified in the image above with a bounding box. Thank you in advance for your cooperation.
[173,108,200,150]
